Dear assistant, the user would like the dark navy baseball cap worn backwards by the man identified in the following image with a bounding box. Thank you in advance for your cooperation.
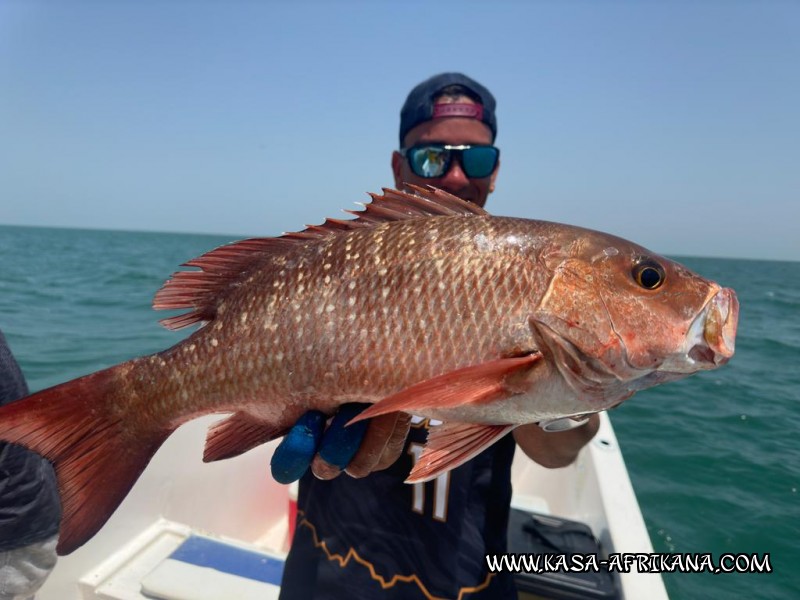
[400,73,497,147]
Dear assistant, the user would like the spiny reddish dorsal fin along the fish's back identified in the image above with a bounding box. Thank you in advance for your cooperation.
[153,184,488,329]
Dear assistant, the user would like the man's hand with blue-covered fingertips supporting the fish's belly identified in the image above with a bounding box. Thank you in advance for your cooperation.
[270,403,411,483]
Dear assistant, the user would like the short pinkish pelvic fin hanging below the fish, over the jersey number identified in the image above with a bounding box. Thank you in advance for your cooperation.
[406,423,516,483]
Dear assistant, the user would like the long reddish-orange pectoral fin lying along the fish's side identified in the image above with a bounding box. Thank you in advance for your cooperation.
[348,352,542,424]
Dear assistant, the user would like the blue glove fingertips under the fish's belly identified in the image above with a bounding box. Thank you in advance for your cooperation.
[270,402,369,483]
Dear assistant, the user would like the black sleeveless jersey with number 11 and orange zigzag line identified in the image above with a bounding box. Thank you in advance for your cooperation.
[281,420,516,600]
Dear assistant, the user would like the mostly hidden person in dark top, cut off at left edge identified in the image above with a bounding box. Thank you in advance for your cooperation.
[0,332,61,600]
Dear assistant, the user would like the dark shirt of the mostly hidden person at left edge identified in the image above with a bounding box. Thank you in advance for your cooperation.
[0,332,61,552]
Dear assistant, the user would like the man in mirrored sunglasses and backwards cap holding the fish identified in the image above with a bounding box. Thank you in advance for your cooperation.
[273,73,599,599]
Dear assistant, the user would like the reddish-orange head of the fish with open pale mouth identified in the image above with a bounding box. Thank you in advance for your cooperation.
[532,232,739,405]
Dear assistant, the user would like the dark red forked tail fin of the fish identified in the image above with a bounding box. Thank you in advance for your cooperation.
[0,364,171,555]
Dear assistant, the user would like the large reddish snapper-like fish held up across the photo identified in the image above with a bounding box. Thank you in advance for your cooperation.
[0,188,738,554]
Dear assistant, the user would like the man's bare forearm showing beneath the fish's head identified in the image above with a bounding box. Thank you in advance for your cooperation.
[514,414,600,469]
